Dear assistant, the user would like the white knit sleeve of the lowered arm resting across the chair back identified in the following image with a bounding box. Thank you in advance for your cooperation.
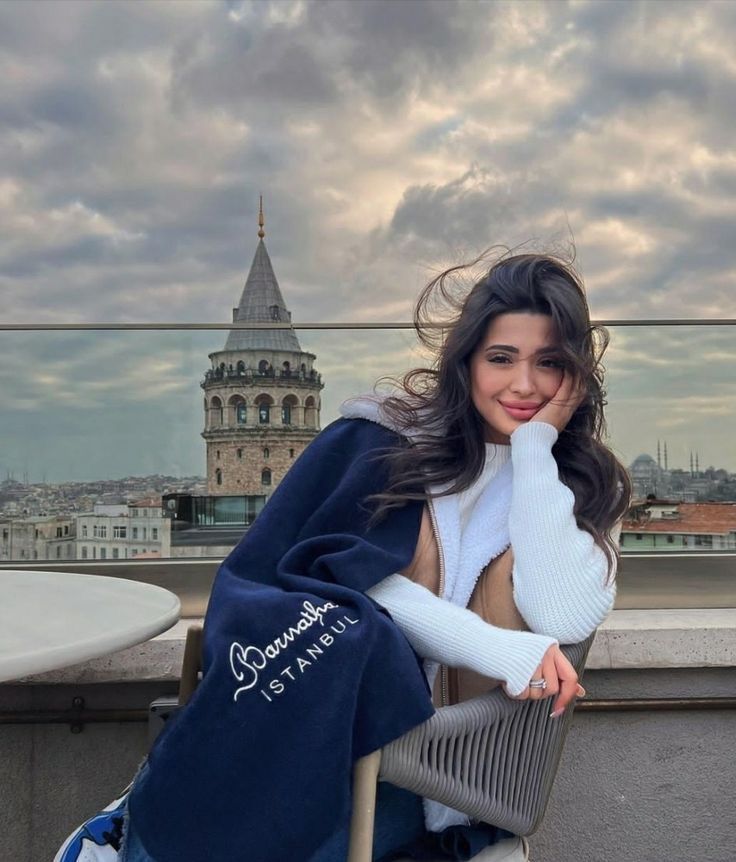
[368,575,556,695]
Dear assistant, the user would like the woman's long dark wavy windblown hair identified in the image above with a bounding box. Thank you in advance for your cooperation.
[374,254,631,573]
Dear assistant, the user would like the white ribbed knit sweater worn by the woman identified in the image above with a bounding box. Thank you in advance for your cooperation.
[369,422,615,694]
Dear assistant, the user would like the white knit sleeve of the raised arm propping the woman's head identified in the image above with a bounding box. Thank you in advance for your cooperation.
[509,422,616,643]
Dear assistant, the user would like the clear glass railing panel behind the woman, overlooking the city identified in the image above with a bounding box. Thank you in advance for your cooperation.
[0,321,736,607]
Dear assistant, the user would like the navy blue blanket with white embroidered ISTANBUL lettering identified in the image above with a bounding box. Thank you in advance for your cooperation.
[130,419,433,862]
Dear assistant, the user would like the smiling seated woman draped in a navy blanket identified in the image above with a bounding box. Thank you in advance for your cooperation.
[60,255,629,862]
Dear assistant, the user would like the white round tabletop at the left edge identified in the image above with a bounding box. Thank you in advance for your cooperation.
[0,569,179,682]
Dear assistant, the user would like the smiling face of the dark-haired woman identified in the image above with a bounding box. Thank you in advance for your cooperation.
[470,312,563,443]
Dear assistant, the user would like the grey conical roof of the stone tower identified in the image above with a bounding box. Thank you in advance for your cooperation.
[225,238,301,353]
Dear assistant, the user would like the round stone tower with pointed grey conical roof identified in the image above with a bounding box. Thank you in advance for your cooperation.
[202,198,323,502]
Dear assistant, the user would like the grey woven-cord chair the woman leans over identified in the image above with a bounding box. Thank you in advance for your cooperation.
[348,635,594,862]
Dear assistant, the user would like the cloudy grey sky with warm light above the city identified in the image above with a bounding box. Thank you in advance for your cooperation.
[0,0,736,481]
